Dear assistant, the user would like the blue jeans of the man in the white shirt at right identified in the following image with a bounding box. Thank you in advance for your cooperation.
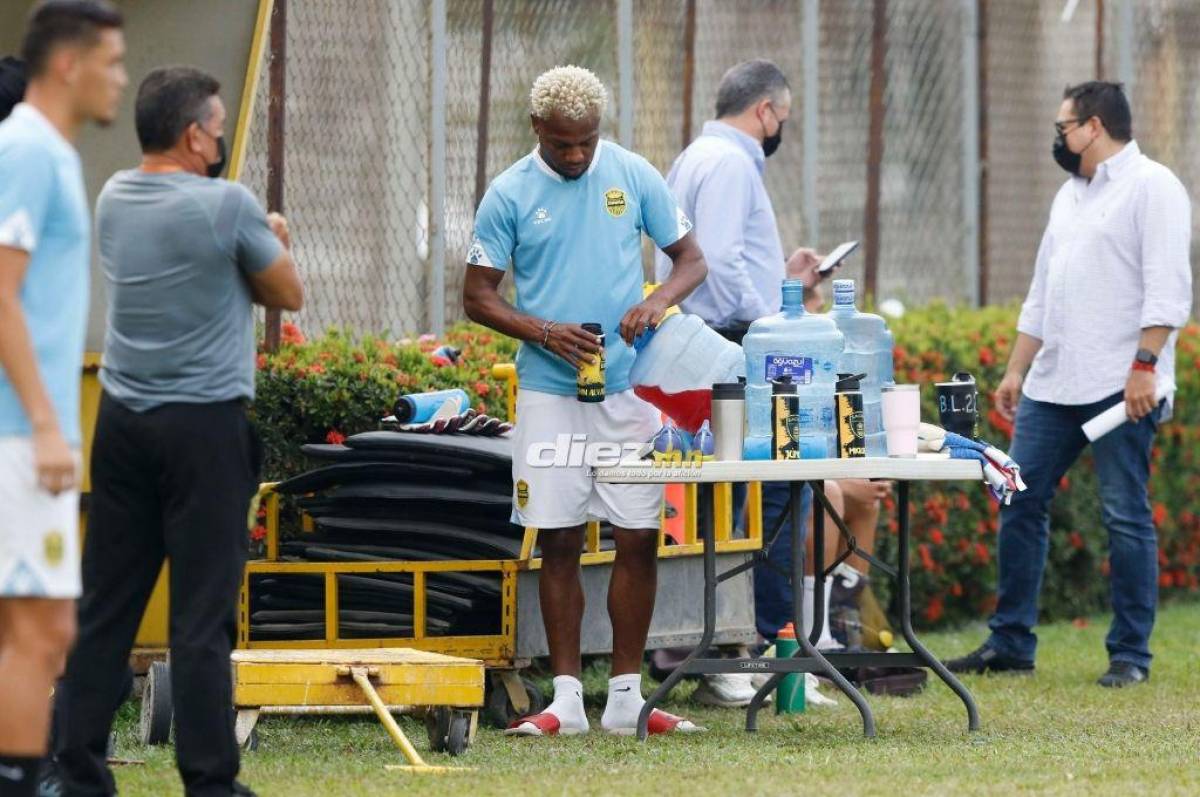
[988,394,1162,669]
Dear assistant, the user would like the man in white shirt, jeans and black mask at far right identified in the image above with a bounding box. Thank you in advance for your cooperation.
[948,82,1192,687]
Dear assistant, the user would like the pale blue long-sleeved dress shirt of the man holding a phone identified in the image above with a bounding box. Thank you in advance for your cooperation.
[655,121,785,328]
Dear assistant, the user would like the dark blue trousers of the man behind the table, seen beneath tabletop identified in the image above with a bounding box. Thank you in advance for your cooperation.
[754,481,812,640]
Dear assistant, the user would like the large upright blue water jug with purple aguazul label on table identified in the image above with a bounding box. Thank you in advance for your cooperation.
[742,280,844,460]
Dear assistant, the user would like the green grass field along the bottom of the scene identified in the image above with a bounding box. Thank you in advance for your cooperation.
[118,604,1200,797]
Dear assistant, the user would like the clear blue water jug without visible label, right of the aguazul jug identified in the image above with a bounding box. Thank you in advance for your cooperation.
[829,280,894,456]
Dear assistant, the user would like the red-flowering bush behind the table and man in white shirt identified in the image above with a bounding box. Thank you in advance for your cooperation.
[876,305,1200,625]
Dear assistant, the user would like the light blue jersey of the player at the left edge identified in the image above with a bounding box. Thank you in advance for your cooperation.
[0,103,91,447]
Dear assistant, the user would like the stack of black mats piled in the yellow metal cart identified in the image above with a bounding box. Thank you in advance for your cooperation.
[250,432,523,641]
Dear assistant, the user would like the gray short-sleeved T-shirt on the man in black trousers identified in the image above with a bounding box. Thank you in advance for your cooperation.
[96,169,282,412]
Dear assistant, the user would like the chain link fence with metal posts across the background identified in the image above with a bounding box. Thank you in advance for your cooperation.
[244,0,1200,335]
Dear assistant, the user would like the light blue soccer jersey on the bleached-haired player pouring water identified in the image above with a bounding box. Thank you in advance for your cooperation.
[467,140,691,396]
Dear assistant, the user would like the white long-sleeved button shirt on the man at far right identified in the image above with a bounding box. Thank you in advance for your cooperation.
[1016,142,1192,405]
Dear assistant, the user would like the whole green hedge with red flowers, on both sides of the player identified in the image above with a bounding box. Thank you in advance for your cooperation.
[254,305,1200,627]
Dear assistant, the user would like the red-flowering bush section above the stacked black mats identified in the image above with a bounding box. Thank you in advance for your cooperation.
[253,323,516,480]
